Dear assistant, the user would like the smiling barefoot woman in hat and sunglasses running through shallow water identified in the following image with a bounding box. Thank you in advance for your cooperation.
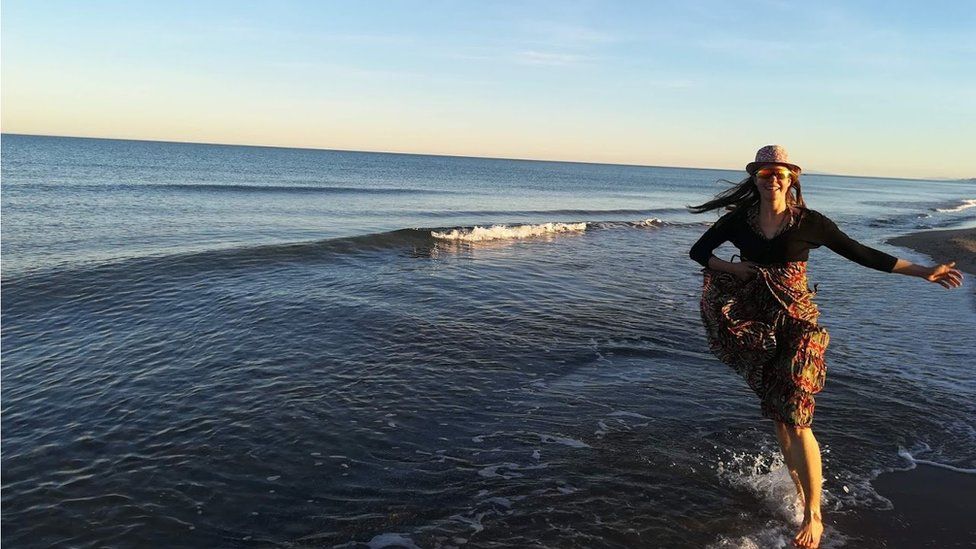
[690,145,962,547]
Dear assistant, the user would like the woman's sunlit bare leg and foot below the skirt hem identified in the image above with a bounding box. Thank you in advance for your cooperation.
[786,427,823,547]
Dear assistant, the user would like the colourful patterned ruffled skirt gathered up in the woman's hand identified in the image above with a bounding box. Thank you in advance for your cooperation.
[701,261,830,427]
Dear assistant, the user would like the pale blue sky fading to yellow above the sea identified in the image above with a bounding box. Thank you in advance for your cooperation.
[0,0,976,178]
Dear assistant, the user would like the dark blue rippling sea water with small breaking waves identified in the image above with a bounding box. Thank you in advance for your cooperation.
[0,135,976,548]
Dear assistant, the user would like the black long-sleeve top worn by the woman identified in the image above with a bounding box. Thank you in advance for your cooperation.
[689,205,898,273]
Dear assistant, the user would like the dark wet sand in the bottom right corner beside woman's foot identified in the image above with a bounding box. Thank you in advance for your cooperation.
[825,464,976,549]
